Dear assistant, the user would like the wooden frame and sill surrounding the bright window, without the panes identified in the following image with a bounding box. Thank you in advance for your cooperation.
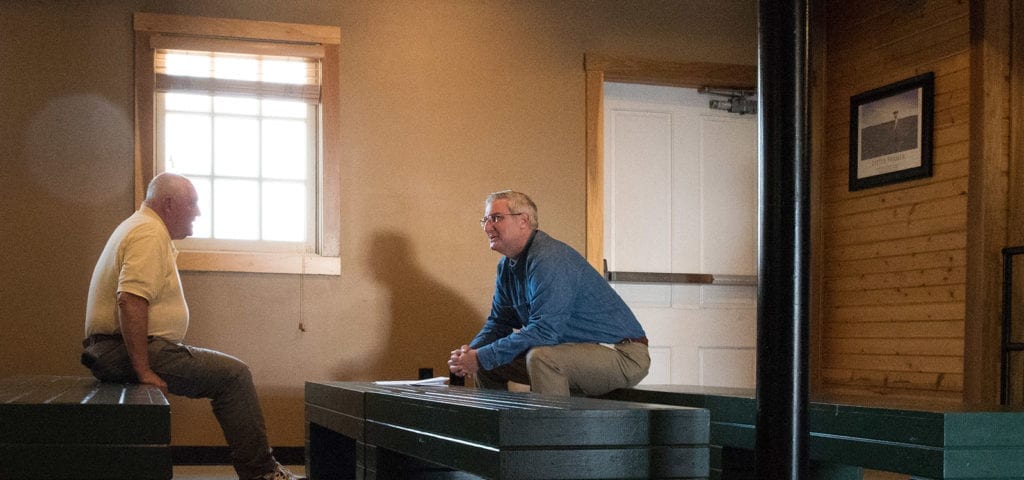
[134,13,341,275]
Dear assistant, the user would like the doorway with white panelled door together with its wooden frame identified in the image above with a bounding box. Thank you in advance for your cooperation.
[587,56,757,387]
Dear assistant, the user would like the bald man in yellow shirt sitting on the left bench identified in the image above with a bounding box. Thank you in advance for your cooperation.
[82,173,301,480]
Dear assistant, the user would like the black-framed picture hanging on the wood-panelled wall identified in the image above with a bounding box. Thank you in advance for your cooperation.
[850,72,935,191]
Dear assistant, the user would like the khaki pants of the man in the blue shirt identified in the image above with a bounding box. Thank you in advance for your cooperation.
[476,343,650,396]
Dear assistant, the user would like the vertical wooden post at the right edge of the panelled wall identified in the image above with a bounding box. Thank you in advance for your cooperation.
[964,0,1011,403]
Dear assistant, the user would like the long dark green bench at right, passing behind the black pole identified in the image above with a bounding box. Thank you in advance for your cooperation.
[606,385,1024,480]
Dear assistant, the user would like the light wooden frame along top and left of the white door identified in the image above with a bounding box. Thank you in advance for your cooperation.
[584,53,758,272]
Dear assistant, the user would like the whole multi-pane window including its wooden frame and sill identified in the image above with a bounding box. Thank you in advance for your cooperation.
[135,13,340,274]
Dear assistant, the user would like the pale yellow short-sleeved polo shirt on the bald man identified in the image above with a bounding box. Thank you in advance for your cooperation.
[85,206,188,342]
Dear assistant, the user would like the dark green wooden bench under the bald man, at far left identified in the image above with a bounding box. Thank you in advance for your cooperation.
[0,376,173,480]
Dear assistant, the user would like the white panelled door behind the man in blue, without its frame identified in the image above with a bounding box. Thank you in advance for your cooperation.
[604,83,758,387]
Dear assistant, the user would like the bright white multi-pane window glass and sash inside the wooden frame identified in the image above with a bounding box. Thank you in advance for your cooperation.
[155,49,319,248]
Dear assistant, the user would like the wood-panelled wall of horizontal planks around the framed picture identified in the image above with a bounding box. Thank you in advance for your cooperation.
[815,0,971,400]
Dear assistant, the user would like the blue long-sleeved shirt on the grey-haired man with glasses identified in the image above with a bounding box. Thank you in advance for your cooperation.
[469,230,645,369]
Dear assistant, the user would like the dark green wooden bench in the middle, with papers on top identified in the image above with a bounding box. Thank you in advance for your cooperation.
[305,382,709,480]
